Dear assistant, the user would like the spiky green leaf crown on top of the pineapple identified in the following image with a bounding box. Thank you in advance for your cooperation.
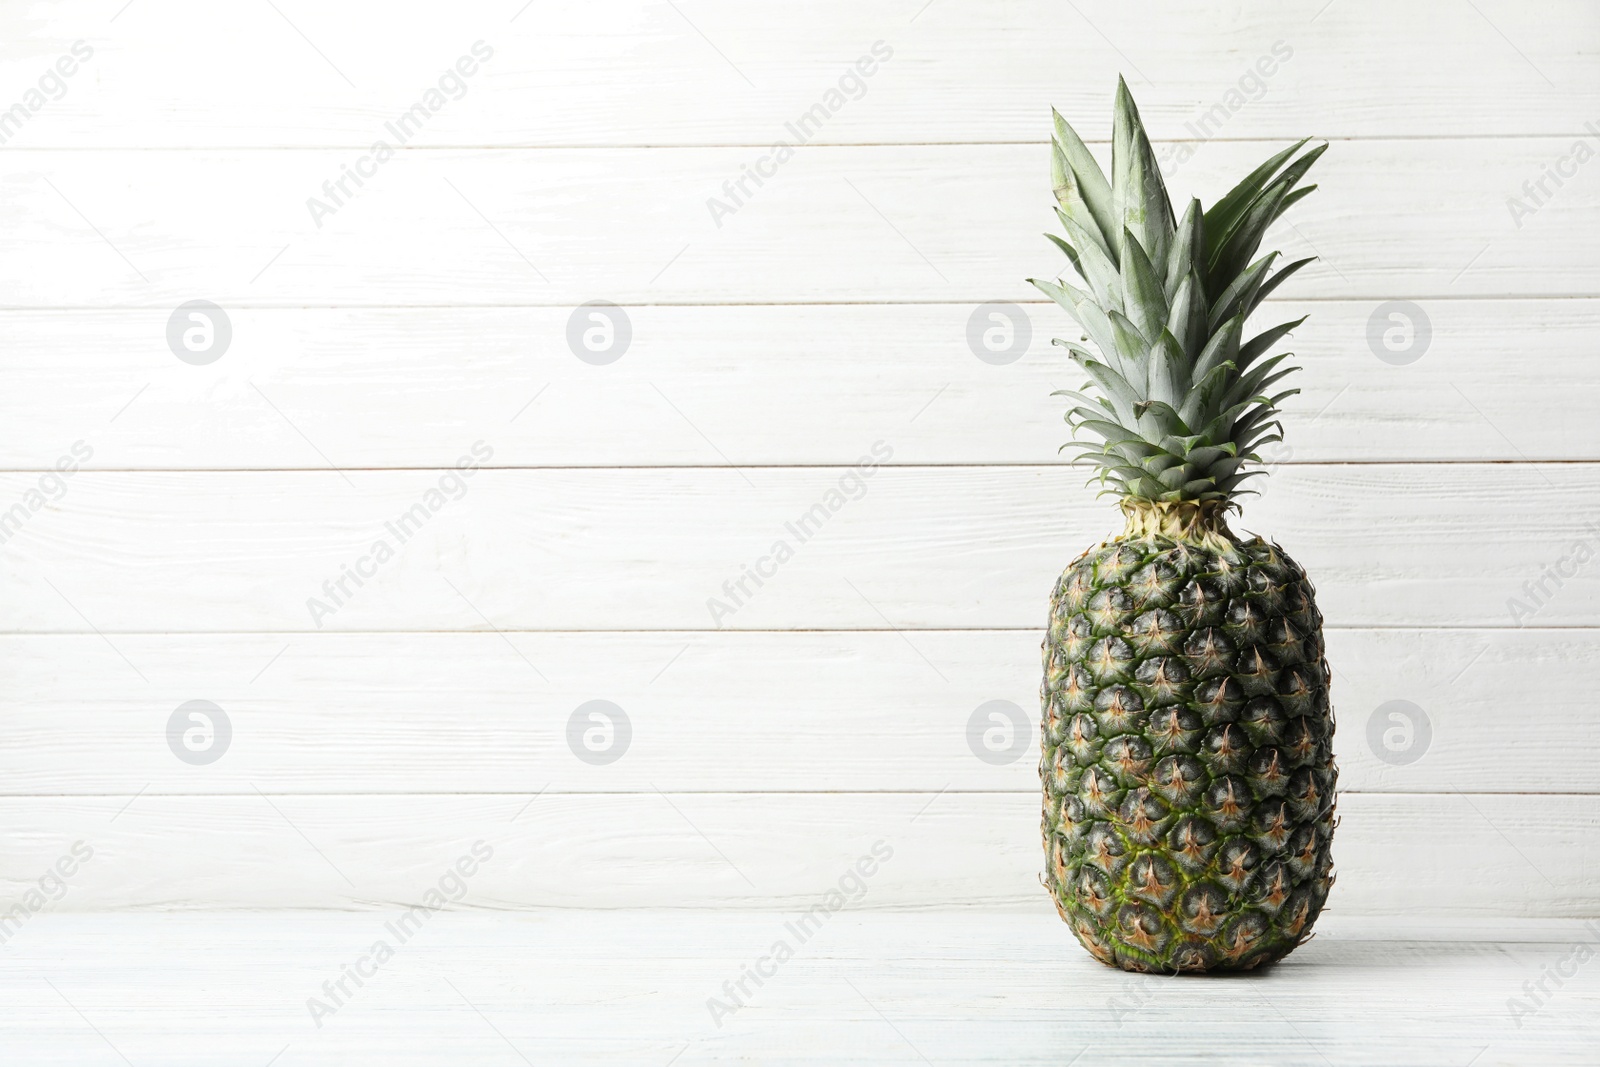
[1029,78,1328,507]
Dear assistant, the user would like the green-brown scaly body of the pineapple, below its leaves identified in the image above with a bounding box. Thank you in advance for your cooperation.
[1040,536,1338,973]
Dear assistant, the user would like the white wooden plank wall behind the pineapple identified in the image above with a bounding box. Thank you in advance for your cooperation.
[0,0,1600,915]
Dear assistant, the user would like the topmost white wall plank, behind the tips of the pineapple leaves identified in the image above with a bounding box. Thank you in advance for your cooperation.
[0,0,1600,147]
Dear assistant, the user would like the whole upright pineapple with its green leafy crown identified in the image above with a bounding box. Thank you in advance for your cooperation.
[1034,83,1338,973]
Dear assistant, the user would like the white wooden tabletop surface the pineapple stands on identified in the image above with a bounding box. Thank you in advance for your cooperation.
[0,905,1600,1067]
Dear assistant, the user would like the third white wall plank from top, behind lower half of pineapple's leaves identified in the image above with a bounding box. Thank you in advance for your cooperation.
[0,301,1600,469]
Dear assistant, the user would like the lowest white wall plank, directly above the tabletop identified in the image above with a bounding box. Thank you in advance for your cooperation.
[0,789,1600,917]
